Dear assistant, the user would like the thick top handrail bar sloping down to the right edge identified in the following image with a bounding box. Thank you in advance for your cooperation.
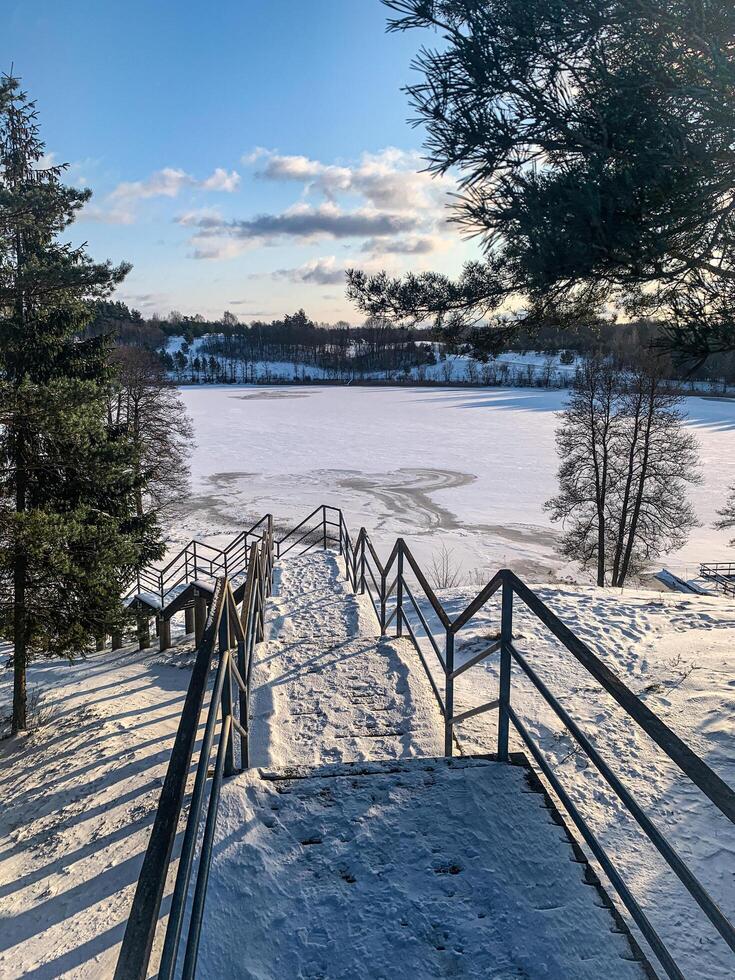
[506,572,735,823]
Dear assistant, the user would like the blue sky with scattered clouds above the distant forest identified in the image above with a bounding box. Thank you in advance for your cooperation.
[0,0,476,322]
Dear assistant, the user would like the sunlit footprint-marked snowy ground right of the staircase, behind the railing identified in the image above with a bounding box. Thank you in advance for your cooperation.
[406,572,735,980]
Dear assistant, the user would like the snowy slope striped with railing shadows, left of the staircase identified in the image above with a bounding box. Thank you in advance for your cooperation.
[0,647,198,980]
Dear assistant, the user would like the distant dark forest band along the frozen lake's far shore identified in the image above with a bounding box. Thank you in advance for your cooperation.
[87,302,735,389]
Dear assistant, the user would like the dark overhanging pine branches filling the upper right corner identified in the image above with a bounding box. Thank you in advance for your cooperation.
[348,0,735,361]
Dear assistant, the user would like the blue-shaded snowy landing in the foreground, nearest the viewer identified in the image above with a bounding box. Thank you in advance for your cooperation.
[198,759,644,980]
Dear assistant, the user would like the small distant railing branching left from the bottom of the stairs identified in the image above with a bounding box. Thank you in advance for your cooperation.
[128,514,273,606]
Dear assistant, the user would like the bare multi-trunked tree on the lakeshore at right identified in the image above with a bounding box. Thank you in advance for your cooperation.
[546,358,700,586]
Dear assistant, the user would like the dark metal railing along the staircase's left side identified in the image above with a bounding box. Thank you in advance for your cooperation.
[115,522,273,980]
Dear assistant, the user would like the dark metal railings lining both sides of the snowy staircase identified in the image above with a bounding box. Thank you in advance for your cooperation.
[115,504,735,980]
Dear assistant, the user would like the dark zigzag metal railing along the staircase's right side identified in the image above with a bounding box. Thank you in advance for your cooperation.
[339,512,735,978]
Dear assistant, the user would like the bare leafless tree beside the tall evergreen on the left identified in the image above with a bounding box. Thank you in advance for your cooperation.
[108,347,194,522]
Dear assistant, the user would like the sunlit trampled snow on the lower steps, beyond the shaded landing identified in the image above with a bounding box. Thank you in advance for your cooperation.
[250,552,443,766]
